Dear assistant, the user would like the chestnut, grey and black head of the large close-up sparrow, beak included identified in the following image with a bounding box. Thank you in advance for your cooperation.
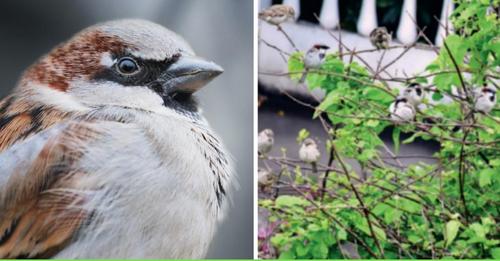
[21,20,223,113]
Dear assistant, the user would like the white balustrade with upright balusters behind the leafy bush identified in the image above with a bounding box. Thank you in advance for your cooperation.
[259,0,453,96]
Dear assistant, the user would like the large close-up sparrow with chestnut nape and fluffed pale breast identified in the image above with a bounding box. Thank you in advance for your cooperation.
[0,20,233,259]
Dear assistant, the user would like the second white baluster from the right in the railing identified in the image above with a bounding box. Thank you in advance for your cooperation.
[396,0,417,44]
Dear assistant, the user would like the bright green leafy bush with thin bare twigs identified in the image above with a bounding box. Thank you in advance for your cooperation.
[259,0,500,258]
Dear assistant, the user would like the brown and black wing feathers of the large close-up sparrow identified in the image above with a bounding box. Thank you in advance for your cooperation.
[0,98,97,258]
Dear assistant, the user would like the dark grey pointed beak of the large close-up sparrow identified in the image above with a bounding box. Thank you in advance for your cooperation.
[161,56,224,94]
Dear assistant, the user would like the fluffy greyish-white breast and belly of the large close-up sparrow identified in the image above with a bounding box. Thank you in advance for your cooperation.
[63,117,229,258]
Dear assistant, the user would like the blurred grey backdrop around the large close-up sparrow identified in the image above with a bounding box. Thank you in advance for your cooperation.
[0,0,253,258]
